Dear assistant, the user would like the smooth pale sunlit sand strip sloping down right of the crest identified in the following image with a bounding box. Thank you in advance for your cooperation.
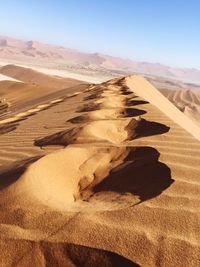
[125,75,200,141]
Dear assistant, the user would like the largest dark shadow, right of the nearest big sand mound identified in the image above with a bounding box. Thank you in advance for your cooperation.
[89,147,174,203]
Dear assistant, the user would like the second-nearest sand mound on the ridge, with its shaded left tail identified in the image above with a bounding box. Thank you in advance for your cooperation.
[35,119,139,146]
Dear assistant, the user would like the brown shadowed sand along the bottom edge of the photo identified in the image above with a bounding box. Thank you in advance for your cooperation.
[0,239,140,267]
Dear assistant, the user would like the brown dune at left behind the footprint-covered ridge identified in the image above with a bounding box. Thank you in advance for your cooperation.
[0,65,87,116]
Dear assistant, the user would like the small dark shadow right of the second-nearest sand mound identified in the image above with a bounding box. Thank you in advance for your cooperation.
[135,119,170,137]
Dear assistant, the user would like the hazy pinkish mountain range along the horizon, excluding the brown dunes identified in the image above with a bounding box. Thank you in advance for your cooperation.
[0,36,200,83]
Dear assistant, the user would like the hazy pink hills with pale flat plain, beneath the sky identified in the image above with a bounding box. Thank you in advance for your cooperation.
[0,36,200,85]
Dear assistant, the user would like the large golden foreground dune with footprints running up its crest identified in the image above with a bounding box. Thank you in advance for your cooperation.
[0,76,200,266]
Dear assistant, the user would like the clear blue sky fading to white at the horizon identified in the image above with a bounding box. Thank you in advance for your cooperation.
[0,0,200,69]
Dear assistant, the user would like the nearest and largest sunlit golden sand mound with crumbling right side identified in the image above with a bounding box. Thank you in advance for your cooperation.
[8,146,128,210]
